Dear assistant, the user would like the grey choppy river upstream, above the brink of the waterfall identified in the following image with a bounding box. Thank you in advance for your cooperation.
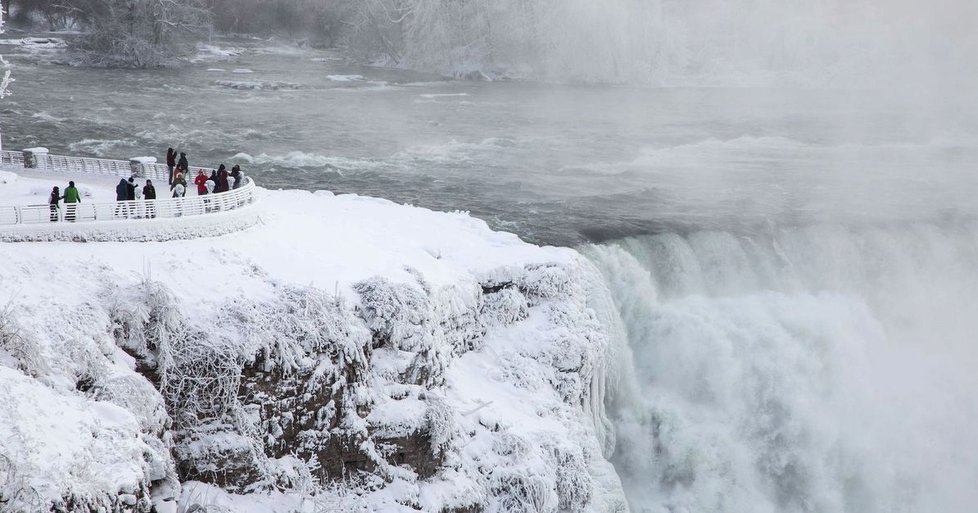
[0,35,978,244]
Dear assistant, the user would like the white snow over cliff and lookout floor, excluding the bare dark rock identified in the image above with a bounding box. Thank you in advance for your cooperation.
[0,169,626,512]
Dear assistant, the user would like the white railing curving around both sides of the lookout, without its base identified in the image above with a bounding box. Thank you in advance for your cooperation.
[0,151,256,225]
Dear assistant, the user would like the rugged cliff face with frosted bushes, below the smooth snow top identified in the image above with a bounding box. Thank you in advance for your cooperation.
[0,260,626,512]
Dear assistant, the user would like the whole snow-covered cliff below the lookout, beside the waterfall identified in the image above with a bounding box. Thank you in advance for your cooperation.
[0,173,627,512]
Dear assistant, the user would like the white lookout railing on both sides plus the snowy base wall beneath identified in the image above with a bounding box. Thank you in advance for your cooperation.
[0,151,258,241]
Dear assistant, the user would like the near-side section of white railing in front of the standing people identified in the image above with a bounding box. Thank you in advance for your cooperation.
[0,177,255,225]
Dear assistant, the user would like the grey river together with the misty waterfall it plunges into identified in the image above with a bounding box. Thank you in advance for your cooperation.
[0,33,978,513]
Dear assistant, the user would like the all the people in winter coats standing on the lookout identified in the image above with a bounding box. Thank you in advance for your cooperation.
[48,148,244,222]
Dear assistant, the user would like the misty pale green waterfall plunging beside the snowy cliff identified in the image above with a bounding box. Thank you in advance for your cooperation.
[584,224,978,513]
